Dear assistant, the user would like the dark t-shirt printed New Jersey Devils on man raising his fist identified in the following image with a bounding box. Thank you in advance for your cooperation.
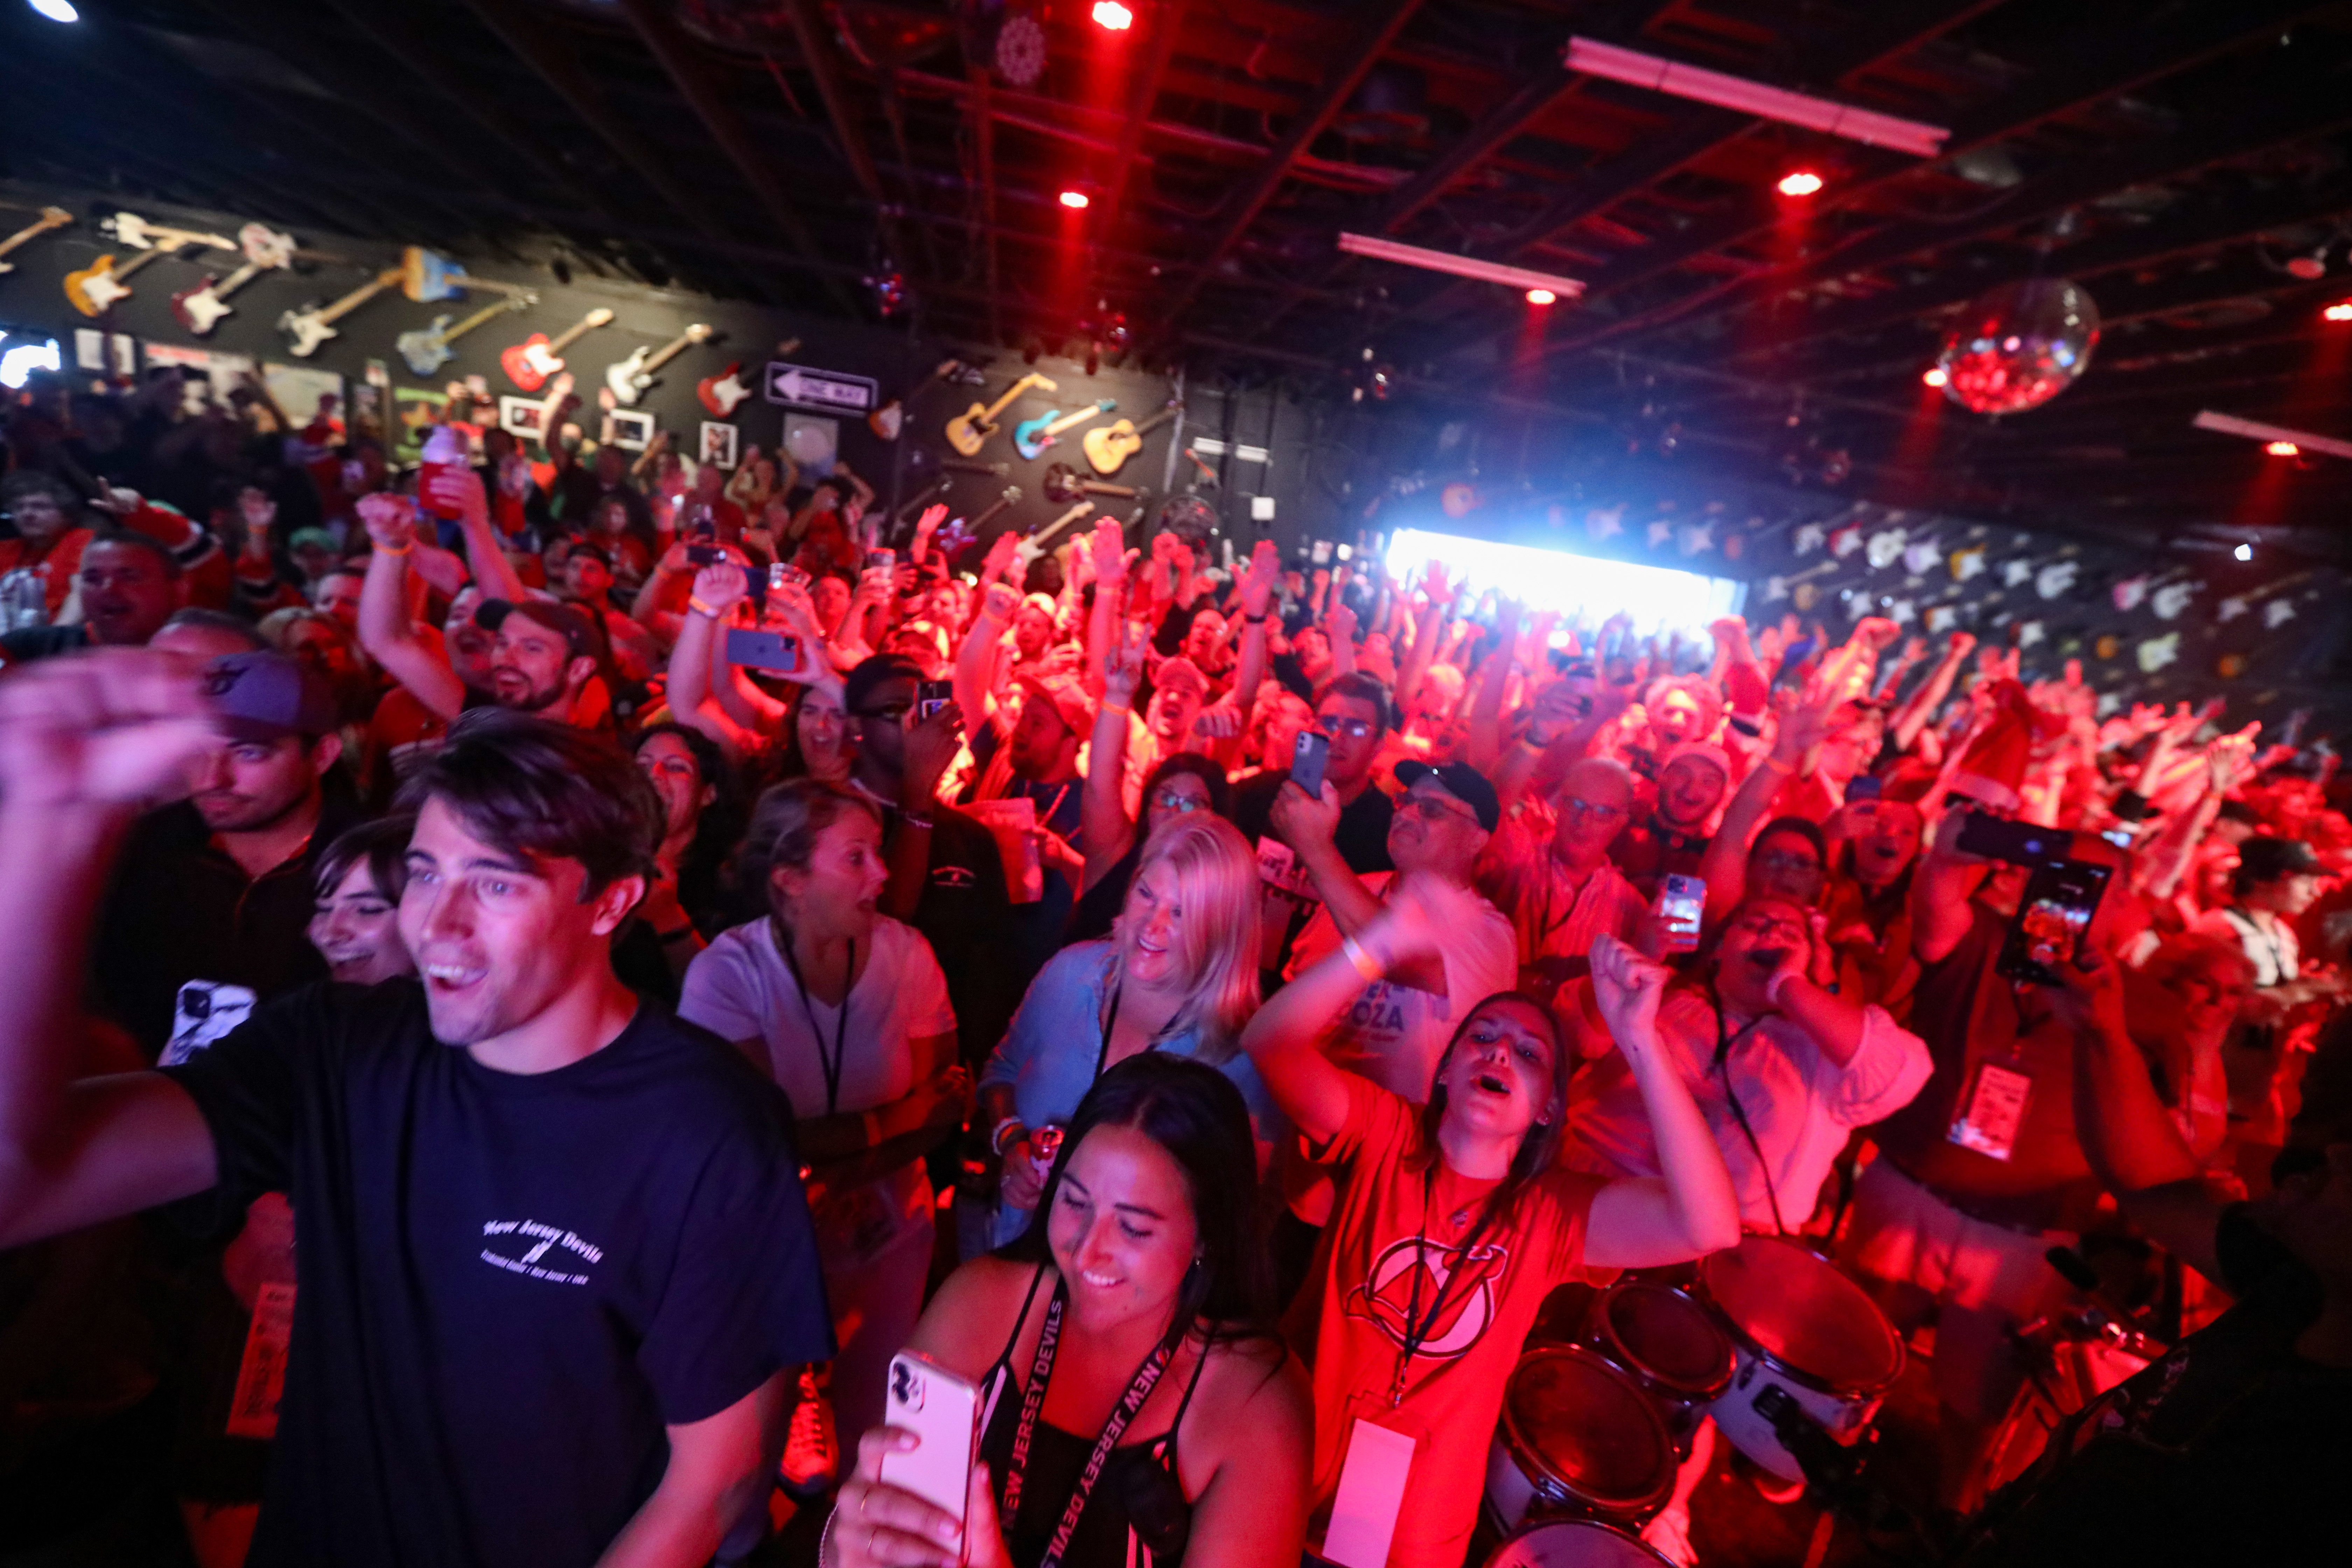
[167,980,833,1568]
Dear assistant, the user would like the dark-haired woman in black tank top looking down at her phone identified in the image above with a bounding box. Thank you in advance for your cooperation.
[819,1053,1312,1568]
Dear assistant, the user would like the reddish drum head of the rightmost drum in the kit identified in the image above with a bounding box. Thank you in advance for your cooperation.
[1698,1237,1903,1394]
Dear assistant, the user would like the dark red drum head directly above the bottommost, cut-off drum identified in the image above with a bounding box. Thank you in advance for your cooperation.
[1503,1345,1675,1514]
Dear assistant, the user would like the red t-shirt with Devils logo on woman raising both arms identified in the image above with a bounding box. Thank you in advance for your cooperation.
[1289,1077,1606,1568]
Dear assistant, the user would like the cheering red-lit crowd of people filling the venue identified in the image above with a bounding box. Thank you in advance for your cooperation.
[0,371,2352,1568]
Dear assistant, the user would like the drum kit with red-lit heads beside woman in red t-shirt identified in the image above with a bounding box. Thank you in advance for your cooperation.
[1486,1237,1903,1568]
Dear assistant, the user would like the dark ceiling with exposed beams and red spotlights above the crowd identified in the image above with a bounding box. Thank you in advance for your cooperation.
[0,0,2352,552]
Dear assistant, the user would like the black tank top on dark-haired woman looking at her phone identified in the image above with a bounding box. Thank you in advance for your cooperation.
[981,1265,1209,1568]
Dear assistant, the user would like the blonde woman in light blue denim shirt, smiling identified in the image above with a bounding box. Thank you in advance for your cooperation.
[979,811,1287,1246]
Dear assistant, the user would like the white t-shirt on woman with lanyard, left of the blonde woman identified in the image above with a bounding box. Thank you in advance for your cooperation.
[677,915,955,1262]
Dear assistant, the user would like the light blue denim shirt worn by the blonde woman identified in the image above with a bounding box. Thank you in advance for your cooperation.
[981,938,1291,1246]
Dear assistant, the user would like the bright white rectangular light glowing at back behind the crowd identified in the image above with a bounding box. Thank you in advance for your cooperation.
[1388,529,1748,637]
